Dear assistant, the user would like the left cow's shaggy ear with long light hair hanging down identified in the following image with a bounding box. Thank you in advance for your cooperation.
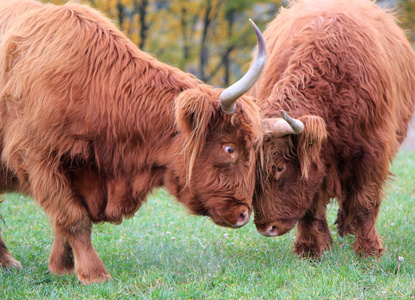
[175,89,214,180]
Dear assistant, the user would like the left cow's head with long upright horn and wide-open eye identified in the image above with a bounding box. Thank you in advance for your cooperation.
[166,23,265,228]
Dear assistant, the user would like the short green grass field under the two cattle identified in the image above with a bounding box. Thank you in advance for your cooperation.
[0,151,415,299]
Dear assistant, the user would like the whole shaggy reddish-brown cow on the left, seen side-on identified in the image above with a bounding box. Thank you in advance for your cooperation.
[0,0,265,283]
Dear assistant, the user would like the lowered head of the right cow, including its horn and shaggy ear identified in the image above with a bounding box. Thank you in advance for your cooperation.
[253,111,327,236]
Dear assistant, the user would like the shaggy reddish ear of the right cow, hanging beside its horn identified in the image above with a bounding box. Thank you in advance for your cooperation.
[297,116,327,178]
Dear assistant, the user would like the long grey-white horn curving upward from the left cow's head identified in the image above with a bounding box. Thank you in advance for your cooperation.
[219,19,267,114]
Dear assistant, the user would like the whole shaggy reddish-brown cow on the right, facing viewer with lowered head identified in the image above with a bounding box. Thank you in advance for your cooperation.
[251,0,415,257]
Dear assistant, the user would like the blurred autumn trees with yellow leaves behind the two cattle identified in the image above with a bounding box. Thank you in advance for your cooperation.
[38,0,415,86]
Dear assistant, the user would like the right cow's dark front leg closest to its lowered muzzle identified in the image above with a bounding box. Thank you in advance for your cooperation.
[294,193,332,259]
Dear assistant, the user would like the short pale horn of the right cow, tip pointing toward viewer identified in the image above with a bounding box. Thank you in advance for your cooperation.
[262,110,304,137]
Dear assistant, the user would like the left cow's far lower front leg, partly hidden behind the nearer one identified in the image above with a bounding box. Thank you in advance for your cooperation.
[48,229,75,275]
